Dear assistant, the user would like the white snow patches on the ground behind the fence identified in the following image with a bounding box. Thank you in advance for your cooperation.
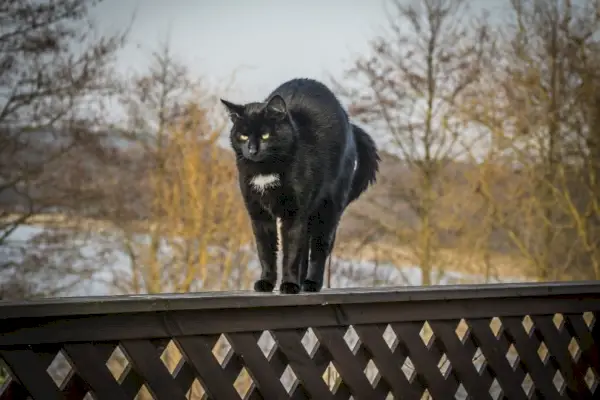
[0,226,525,296]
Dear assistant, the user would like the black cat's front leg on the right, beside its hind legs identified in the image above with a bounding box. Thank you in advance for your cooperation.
[279,215,308,294]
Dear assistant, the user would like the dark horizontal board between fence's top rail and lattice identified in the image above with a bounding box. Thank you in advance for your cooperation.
[0,295,600,346]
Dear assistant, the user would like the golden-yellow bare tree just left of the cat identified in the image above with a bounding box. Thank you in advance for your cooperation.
[98,45,252,293]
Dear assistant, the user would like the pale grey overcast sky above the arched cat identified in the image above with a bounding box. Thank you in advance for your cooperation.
[95,0,508,101]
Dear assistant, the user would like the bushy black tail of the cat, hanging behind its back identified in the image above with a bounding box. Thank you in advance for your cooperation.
[348,124,381,204]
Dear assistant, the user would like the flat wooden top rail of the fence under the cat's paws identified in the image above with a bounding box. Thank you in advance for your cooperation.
[0,281,600,320]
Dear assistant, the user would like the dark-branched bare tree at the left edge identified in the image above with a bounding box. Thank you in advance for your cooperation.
[0,0,125,296]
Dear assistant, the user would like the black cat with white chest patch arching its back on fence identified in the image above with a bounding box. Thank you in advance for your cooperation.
[221,79,380,293]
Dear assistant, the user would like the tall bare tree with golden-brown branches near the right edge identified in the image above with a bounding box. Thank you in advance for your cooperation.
[463,0,600,280]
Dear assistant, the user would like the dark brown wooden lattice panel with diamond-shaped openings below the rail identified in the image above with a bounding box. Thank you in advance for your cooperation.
[0,313,600,400]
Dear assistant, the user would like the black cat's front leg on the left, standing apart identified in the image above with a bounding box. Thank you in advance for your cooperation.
[250,209,277,292]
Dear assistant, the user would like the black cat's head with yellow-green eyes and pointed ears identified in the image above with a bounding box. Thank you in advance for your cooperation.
[221,95,296,162]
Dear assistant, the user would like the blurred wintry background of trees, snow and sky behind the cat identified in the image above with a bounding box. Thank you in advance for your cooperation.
[0,0,600,299]
